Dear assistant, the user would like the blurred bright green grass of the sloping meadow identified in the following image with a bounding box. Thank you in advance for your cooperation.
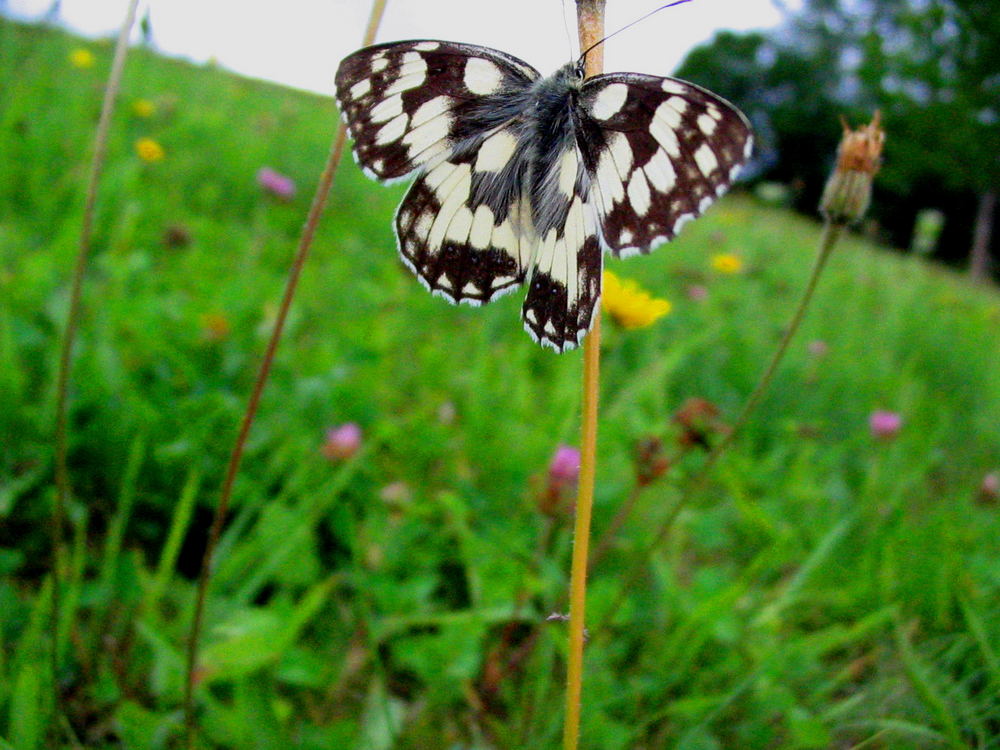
[0,17,1000,750]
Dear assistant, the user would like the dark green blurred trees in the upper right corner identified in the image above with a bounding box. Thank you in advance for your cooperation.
[679,0,1000,273]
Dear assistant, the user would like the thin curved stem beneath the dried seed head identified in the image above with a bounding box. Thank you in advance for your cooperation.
[597,221,844,631]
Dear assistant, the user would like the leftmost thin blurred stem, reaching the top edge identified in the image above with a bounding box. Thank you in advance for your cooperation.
[49,0,139,725]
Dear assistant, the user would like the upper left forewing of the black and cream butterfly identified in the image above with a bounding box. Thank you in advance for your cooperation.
[336,39,539,181]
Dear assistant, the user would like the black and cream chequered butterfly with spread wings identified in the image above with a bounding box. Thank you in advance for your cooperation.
[336,40,753,352]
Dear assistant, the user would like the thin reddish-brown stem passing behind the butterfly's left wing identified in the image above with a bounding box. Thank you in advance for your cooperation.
[184,0,387,747]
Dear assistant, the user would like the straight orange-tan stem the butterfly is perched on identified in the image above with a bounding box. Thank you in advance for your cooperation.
[563,7,604,750]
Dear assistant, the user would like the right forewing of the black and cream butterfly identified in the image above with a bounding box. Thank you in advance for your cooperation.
[576,73,753,256]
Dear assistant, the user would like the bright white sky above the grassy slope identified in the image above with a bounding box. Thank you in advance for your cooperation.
[6,0,801,94]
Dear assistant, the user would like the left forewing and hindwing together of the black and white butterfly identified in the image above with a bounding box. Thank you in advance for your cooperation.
[336,40,539,305]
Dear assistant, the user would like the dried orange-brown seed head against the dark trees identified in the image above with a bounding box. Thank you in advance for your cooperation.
[819,110,885,224]
